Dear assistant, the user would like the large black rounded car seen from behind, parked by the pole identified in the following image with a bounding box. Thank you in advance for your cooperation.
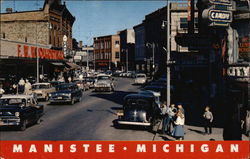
[116,93,161,131]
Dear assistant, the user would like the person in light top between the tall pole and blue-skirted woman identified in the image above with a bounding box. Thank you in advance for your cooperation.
[165,104,177,134]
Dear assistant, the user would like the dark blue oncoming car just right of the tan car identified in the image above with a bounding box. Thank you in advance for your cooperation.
[49,83,82,105]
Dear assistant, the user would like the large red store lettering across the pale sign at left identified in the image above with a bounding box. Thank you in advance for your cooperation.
[17,45,64,60]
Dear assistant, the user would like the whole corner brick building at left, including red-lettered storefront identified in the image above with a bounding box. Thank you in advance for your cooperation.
[0,0,75,79]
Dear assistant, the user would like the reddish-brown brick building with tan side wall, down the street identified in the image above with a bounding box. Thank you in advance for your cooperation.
[94,35,120,70]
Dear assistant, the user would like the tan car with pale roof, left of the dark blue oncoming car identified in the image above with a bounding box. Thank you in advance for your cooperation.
[32,83,56,101]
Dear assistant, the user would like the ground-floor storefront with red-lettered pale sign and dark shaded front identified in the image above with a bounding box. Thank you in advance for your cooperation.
[0,39,65,82]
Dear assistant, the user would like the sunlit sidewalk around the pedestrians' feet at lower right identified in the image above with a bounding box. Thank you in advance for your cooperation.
[155,125,250,141]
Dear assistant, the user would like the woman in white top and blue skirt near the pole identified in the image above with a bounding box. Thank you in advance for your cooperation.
[172,110,185,140]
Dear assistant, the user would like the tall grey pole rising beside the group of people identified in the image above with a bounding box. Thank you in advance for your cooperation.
[166,0,171,106]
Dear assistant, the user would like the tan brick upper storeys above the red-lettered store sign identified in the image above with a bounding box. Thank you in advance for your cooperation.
[0,0,75,50]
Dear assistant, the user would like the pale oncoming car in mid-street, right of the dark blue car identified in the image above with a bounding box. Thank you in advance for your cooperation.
[95,74,114,92]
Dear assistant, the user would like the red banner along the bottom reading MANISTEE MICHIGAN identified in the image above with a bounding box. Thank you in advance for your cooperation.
[0,141,250,159]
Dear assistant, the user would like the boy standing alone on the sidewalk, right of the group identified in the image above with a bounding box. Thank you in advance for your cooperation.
[203,106,213,134]
